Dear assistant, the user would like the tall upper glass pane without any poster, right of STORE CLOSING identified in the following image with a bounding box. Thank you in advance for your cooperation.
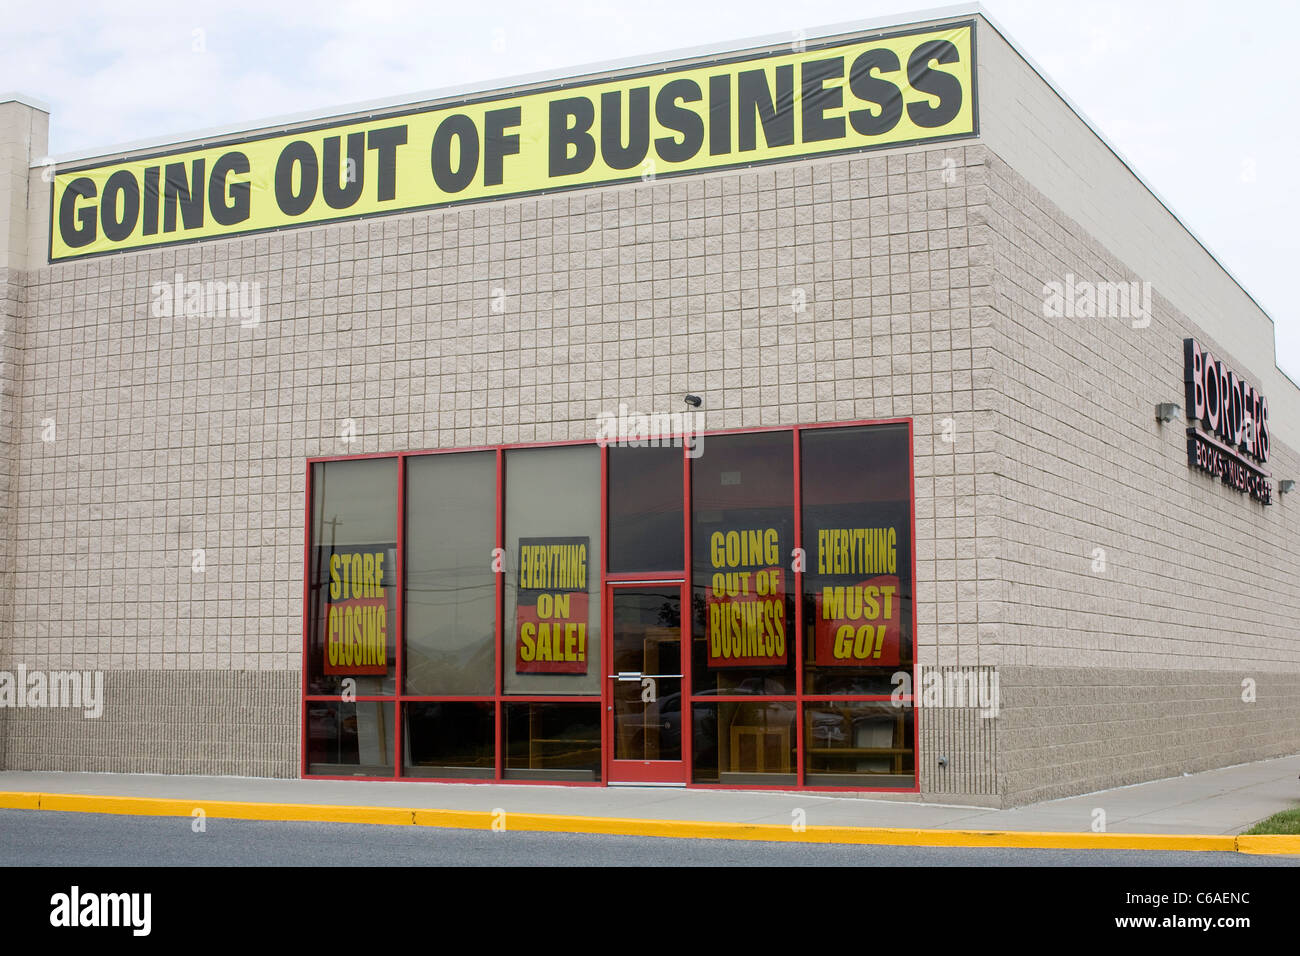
[402,451,497,697]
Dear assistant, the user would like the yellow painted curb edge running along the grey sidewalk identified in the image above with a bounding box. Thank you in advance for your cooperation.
[0,792,1300,855]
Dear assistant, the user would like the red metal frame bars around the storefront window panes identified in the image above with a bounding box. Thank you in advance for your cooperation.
[299,418,920,793]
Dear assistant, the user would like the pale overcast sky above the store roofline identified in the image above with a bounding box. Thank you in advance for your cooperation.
[0,0,1300,381]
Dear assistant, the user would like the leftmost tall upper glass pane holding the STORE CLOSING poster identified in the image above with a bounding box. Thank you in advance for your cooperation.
[307,458,398,696]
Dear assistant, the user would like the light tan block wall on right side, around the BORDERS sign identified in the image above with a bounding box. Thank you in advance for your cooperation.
[982,145,1300,674]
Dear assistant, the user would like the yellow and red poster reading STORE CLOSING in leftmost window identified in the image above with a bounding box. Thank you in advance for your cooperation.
[325,549,389,675]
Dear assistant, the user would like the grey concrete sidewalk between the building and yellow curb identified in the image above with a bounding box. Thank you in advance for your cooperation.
[0,754,1300,835]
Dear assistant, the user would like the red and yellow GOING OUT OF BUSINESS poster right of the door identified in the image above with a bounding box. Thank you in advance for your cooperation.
[705,528,788,667]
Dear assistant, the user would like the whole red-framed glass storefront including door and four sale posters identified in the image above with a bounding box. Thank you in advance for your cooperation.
[303,421,917,790]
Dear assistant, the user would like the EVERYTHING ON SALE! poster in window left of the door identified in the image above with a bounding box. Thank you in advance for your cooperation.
[515,537,590,674]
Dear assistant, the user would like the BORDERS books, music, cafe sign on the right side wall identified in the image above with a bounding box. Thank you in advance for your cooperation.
[1183,338,1273,505]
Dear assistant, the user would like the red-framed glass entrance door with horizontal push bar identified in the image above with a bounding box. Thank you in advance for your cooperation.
[606,580,686,786]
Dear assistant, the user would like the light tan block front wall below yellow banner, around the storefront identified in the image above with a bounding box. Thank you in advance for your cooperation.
[13,147,995,773]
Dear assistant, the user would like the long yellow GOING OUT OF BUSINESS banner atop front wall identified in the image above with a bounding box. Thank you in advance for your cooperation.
[49,23,976,261]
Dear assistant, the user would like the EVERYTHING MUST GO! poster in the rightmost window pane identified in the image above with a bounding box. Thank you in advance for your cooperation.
[805,528,902,667]
